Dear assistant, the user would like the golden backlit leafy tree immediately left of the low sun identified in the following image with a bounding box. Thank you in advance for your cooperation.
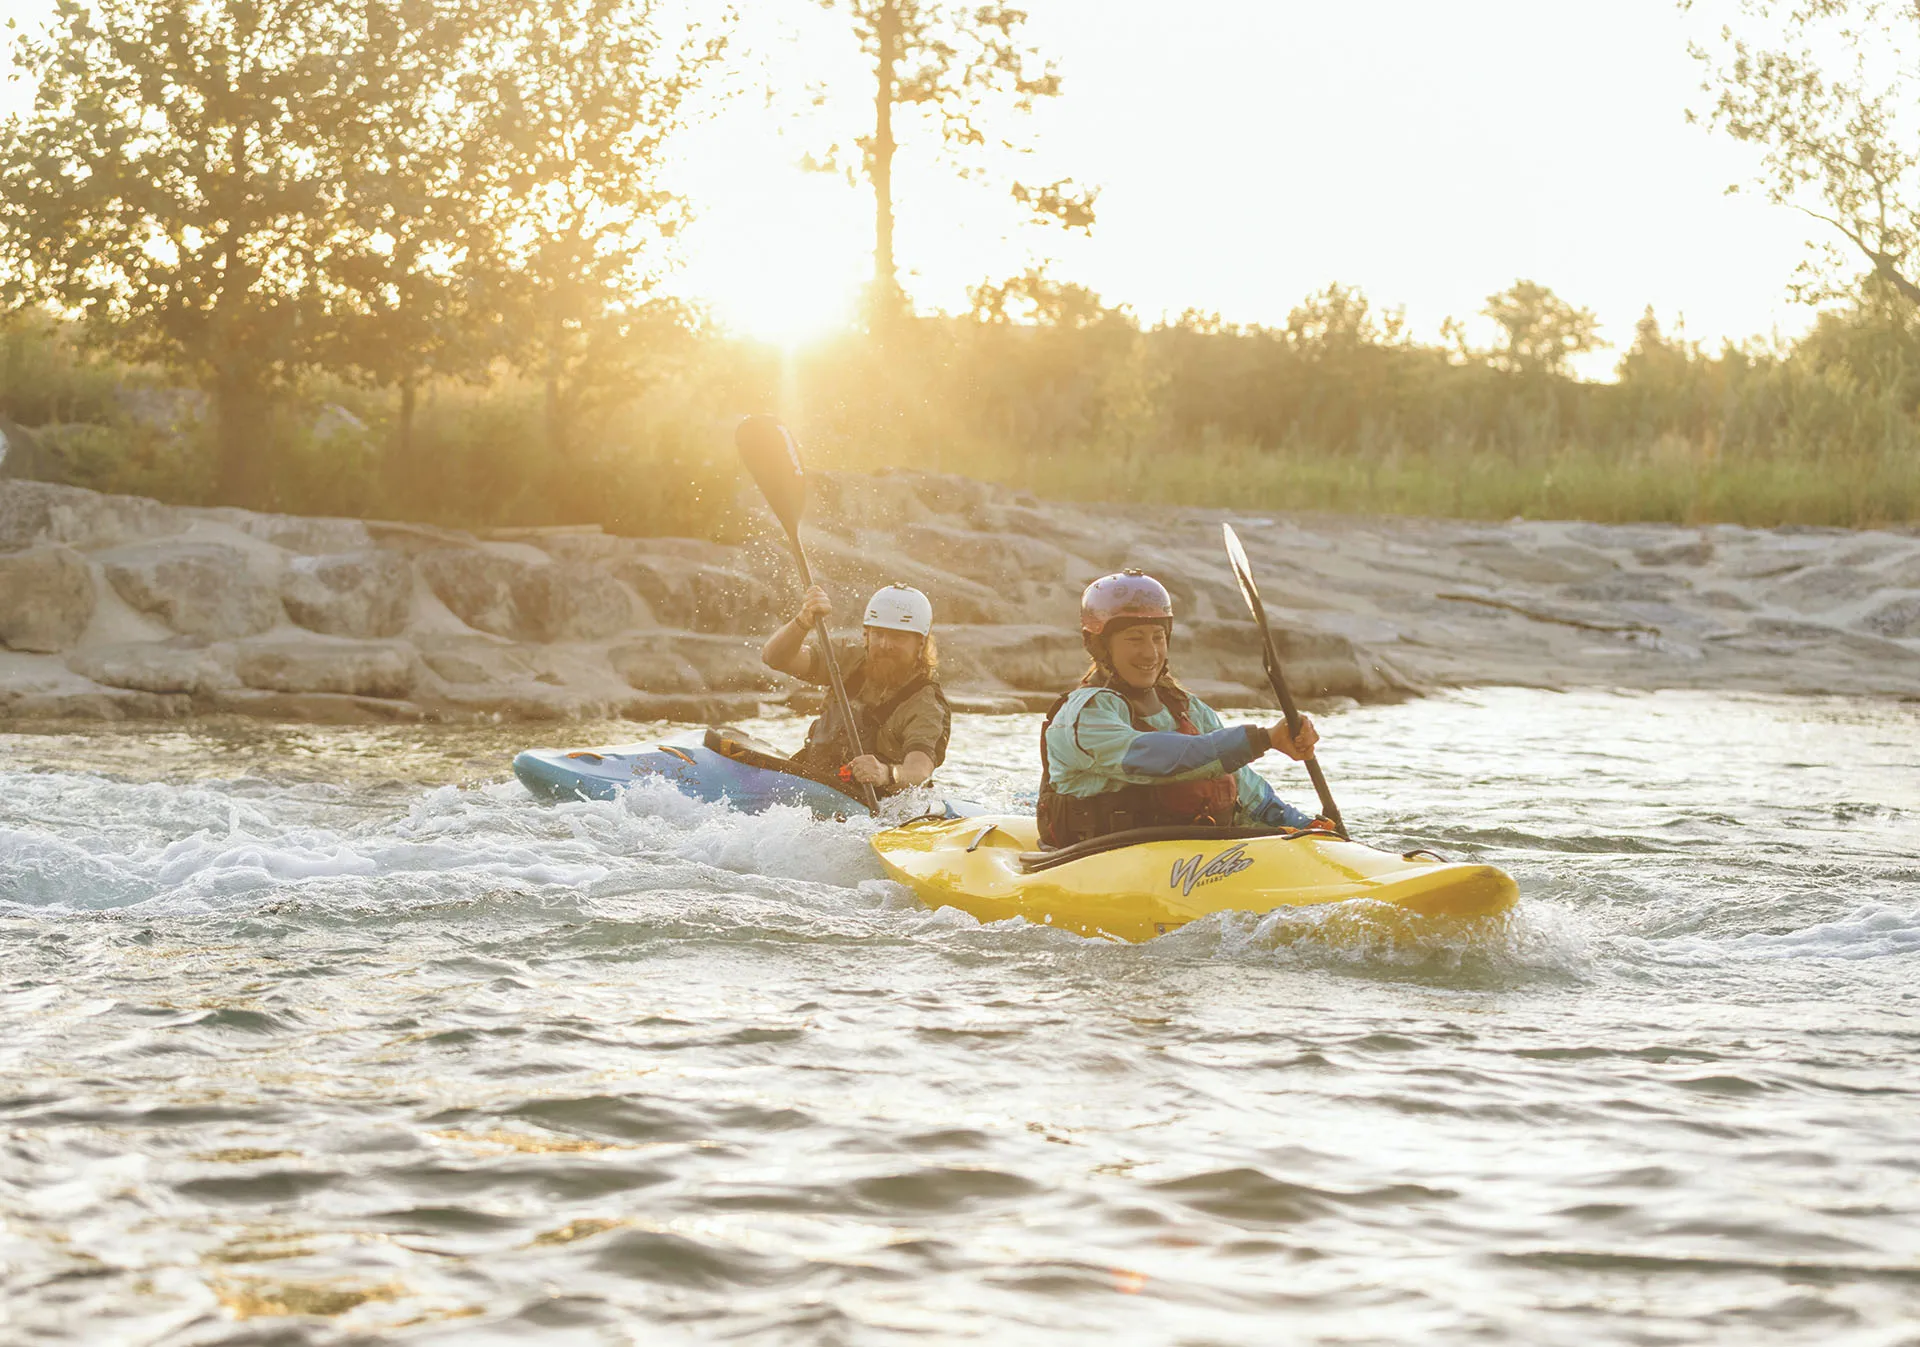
[470,0,726,464]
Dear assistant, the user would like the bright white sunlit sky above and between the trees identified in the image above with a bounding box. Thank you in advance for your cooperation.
[0,0,1816,376]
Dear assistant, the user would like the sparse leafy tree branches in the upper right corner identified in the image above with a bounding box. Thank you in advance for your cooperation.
[1684,0,1920,303]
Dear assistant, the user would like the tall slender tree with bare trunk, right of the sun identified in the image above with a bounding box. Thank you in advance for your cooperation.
[820,0,1098,320]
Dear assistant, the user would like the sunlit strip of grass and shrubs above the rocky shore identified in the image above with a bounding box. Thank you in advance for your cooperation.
[0,290,1920,537]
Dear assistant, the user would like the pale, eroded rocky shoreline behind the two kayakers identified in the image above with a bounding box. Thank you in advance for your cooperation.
[0,472,1920,723]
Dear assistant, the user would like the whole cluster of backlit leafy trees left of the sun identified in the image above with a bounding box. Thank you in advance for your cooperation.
[0,0,720,505]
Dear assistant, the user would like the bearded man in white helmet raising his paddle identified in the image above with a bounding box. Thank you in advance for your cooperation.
[760,585,952,794]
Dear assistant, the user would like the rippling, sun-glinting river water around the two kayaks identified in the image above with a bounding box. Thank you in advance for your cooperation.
[0,691,1920,1345]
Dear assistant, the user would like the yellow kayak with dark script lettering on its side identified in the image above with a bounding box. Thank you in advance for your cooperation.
[874,815,1519,940]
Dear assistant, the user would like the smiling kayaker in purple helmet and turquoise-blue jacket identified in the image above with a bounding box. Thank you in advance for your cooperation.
[1039,570,1319,848]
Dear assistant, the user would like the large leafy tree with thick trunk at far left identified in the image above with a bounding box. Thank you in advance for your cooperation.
[0,0,355,501]
